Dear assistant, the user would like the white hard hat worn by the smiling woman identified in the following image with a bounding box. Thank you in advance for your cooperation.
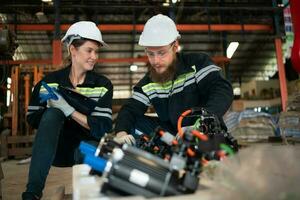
[61,21,108,46]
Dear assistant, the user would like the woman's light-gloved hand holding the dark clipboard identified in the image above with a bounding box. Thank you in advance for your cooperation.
[47,92,75,117]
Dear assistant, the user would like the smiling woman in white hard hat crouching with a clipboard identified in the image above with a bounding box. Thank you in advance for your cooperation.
[22,21,113,199]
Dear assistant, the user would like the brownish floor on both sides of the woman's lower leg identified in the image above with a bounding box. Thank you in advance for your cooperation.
[1,160,72,200]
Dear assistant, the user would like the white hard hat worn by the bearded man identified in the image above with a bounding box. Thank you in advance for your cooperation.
[139,14,180,47]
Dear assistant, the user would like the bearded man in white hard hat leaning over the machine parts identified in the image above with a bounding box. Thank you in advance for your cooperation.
[115,14,233,144]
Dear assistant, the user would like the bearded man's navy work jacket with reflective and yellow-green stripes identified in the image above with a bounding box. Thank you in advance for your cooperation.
[115,53,233,137]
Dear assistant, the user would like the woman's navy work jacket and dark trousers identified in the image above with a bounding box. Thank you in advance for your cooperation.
[27,66,113,195]
